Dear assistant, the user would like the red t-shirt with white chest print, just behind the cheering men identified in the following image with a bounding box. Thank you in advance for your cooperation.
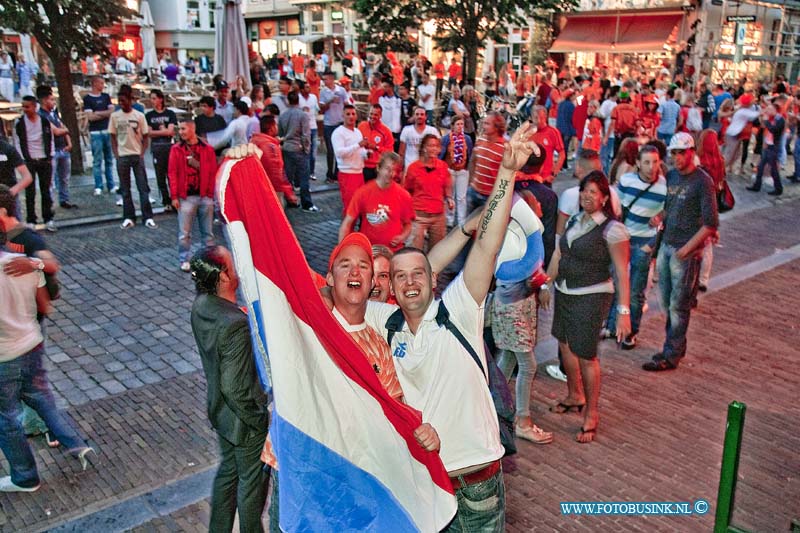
[347,180,415,251]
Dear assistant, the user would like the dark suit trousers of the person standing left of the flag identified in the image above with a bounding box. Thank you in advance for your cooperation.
[208,432,269,533]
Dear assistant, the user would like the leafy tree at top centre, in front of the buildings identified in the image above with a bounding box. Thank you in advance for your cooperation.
[352,0,578,80]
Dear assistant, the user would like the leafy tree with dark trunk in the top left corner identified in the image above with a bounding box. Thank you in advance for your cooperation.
[0,0,137,173]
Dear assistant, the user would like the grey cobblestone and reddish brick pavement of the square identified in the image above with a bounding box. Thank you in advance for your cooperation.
[0,172,800,532]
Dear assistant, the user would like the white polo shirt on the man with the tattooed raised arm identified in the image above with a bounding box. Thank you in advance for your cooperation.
[366,274,505,472]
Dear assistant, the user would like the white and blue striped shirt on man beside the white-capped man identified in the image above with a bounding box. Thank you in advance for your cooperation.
[617,172,667,238]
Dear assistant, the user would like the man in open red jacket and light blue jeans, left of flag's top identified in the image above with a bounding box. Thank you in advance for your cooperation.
[167,118,217,272]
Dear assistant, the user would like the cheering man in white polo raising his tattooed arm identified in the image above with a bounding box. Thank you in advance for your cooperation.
[366,123,535,533]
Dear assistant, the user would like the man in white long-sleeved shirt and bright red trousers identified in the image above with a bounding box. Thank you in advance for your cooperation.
[331,104,368,213]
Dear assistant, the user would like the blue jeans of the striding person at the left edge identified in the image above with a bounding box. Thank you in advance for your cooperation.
[0,344,86,487]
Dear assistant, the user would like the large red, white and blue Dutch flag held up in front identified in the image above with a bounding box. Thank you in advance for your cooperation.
[217,156,456,532]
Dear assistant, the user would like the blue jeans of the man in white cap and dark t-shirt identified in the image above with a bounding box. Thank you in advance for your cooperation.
[656,243,702,365]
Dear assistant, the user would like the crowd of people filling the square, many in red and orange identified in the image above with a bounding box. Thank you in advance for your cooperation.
[0,45,800,531]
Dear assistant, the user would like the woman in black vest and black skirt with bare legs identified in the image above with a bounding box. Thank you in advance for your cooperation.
[539,170,631,443]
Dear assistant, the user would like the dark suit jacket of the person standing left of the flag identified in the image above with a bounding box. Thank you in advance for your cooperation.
[192,294,269,445]
